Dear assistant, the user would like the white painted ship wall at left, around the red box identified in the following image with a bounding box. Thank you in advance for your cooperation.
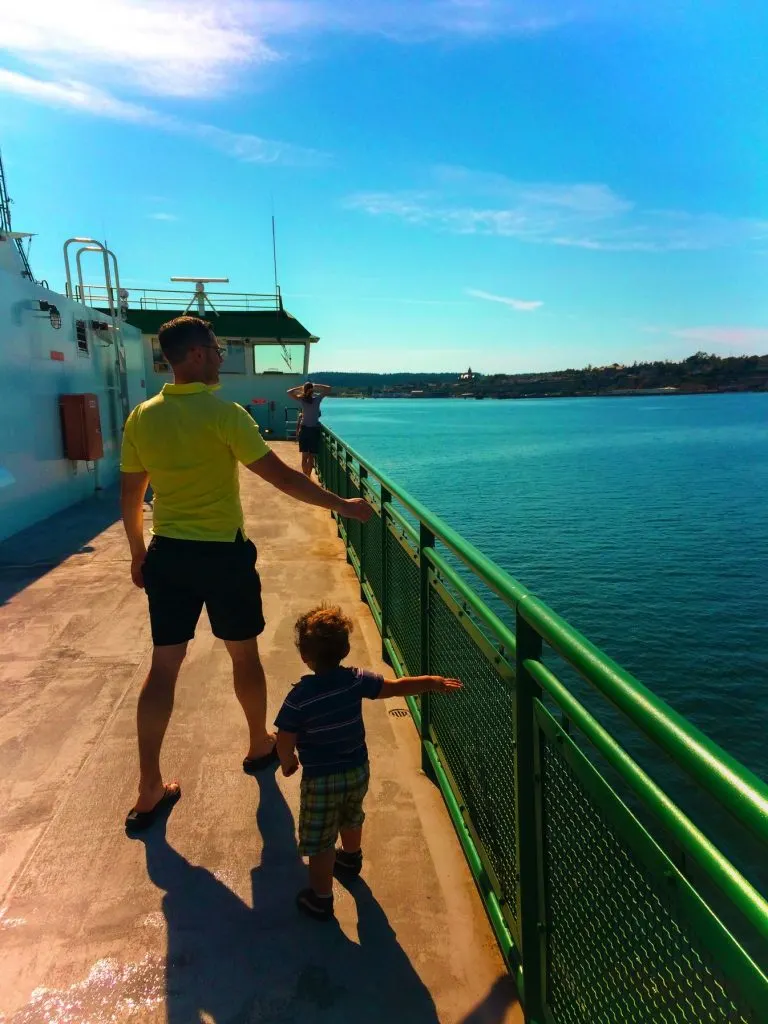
[0,250,145,540]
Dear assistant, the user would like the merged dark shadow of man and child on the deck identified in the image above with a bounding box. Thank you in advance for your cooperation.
[138,771,438,1024]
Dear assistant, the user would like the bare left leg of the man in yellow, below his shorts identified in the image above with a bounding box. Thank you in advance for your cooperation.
[135,643,186,811]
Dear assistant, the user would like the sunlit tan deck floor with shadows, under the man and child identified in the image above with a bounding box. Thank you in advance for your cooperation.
[0,443,522,1024]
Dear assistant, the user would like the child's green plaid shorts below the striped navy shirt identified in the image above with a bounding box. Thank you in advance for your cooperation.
[299,761,371,857]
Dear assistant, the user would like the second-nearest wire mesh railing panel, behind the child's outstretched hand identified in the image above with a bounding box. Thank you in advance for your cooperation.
[429,588,517,933]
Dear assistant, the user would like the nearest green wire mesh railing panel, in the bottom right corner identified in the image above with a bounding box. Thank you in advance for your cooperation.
[542,737,759,1024]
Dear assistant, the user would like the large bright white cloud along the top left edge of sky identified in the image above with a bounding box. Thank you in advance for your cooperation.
[0,0,581,103]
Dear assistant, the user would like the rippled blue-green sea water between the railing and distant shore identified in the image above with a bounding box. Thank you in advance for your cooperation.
[323,394,768,778]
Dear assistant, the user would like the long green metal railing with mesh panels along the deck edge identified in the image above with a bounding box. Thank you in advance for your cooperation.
[318,428,768,1024]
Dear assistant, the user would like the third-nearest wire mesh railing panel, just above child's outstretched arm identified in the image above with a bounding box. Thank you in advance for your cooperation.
[385,529,421,676]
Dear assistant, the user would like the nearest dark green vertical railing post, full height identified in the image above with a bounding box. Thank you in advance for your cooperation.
[515,606,547,1021]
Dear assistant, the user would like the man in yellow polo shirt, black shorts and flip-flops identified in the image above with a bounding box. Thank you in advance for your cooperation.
[121,316,372,833]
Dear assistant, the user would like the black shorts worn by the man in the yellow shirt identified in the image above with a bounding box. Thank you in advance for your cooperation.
[143,534,264,647]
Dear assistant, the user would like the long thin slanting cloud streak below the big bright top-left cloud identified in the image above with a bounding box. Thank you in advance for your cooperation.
[0,68,330,167]
